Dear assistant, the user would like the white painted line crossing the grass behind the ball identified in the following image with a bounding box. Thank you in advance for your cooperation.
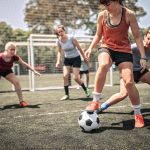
[0,103,150,121]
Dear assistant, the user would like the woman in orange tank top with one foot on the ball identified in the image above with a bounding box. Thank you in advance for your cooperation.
[85,0,146,128]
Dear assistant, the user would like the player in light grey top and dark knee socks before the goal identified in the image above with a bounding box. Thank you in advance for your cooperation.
[55,25,90,100]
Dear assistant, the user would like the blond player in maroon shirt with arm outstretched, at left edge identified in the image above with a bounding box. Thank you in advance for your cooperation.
[0,42,40,107]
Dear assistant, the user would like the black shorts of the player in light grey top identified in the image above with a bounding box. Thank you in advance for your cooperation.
[64,56,81,68]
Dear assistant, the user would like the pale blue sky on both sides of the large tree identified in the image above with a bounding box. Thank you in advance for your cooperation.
[0,0,150,30]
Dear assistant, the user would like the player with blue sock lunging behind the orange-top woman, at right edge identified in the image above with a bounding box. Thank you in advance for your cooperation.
[96,31,150,113]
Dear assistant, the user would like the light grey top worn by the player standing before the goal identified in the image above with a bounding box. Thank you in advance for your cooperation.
[56,35,80,58]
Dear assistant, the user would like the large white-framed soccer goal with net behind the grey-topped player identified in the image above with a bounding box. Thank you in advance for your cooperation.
[28,34,113,91]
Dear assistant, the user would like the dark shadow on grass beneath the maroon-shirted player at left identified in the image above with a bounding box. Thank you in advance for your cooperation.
[0,104,42,111]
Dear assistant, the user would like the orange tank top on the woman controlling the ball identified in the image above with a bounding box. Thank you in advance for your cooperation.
[101,8,132,53]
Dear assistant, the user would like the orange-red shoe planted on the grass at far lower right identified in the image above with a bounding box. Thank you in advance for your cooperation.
[135,114,144,128]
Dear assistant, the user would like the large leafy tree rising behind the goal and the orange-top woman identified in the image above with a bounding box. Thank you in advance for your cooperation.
[25,0,146,34]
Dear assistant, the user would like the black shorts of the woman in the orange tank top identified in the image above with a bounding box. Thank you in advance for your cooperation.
[98,48,133,66]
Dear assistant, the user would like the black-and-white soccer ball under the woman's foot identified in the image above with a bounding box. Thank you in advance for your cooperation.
[78,110,100,132]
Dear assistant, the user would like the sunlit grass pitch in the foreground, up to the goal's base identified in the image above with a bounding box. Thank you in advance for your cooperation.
[0,72,150,150]
